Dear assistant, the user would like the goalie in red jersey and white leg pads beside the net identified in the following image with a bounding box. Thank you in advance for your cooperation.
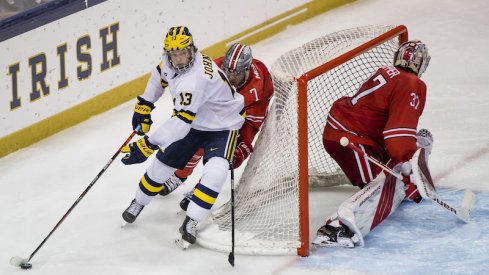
[313,40,433,247]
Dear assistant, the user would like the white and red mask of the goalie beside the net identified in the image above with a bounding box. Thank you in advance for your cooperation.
[394,40,431,77]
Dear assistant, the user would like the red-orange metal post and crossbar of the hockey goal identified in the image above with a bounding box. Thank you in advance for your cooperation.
[297,25,408,256]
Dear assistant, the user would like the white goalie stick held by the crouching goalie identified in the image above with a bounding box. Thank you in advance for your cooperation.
[340,137,475,223]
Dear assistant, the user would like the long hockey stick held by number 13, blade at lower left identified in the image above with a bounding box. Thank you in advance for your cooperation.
[10,126,140,269]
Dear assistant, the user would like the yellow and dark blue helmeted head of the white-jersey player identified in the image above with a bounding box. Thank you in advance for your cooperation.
[163,26,197,73]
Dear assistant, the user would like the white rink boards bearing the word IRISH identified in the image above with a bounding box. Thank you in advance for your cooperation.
[0,0,308,138]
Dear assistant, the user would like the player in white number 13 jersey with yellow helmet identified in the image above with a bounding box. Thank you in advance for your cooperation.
[122,26,244,248]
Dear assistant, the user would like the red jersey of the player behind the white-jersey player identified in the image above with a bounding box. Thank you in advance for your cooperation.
[214,57,273,144]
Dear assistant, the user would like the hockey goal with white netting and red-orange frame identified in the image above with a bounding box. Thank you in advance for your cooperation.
[197,26,407,256]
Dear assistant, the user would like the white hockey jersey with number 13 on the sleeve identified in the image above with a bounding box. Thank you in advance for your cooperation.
[138,52,244,148]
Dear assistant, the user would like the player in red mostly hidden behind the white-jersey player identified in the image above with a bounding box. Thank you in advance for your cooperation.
[160,43,273,209]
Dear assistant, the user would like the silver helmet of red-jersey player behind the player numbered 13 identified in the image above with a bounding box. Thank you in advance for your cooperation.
[222,43,253,89]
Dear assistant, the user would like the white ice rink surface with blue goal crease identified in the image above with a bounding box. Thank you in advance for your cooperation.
[0,0,489,275]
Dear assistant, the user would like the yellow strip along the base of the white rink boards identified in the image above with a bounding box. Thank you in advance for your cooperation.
[0,0,355,158]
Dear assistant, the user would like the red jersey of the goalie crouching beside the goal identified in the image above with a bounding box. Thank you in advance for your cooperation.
[323,66,426,163]
